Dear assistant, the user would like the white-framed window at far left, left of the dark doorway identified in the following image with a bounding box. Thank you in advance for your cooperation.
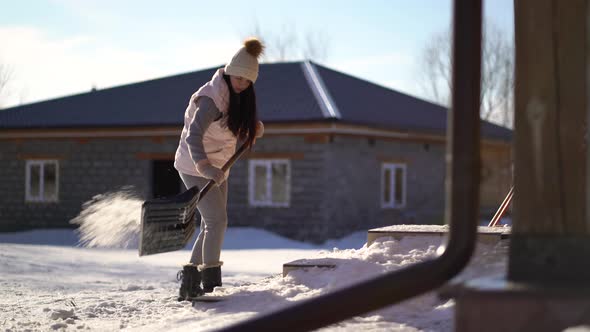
[25,160,59,202]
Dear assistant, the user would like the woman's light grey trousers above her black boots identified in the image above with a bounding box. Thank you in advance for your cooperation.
[179,172,227,268]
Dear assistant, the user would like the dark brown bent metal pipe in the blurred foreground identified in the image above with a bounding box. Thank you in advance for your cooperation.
[220,0,482,332]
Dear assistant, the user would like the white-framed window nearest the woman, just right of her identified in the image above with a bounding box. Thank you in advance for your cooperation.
[248,159,291,207]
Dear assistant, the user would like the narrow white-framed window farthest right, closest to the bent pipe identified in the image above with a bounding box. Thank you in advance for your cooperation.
[381,163,406,209]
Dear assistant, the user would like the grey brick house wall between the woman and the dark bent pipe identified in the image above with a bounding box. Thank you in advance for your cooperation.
[228,135,444,242]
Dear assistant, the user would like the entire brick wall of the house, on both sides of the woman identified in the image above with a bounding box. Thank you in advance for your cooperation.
[0,131,509,243]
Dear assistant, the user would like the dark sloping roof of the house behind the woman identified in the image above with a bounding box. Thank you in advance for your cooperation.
[0,62,512,141]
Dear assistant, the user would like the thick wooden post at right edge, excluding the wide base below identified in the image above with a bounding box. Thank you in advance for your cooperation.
[508,0,590,283]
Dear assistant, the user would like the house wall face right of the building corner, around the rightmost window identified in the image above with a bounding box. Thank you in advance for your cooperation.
[326,136,444,236]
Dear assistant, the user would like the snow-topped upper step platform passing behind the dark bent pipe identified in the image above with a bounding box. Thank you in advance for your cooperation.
[367,225,511,246]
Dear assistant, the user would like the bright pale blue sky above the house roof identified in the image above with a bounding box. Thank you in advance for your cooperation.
[0,0,513,106]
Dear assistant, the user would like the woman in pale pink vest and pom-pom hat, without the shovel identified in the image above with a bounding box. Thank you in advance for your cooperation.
[174,38,264,301]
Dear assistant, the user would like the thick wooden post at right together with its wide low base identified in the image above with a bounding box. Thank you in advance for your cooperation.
[448,0,590,332]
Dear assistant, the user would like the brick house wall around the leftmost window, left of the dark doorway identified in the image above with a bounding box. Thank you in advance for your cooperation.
[0,138,166,230]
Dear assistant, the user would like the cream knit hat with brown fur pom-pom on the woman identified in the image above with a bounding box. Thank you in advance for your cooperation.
[225,38,264,83]
